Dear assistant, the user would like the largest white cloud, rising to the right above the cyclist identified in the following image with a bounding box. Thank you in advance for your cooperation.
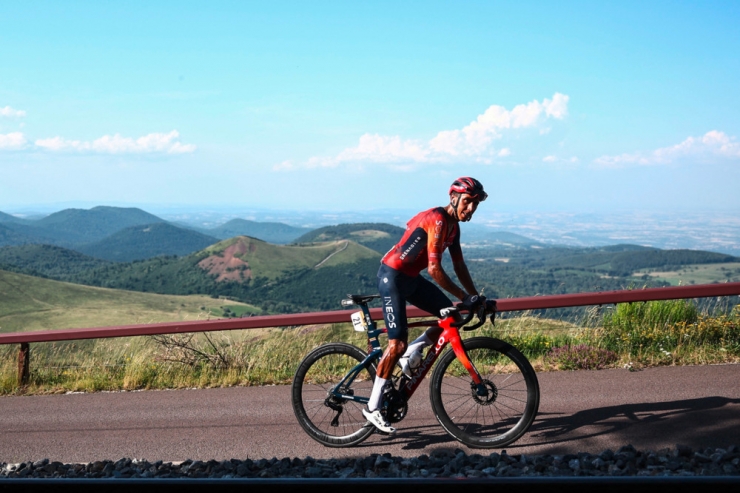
[280,93,569,170]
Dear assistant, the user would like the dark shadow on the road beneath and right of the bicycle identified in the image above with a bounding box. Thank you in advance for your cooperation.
[352,396,740,453]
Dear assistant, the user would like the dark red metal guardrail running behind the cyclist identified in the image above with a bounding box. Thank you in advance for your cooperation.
[0,282,740,385]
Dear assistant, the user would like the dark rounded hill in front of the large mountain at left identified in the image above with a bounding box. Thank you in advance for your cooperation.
[76,222,218,262]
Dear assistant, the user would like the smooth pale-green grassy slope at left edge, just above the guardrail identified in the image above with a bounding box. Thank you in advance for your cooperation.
[0,270,260,332]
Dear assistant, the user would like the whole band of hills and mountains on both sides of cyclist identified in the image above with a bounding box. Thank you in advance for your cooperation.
[0,207,740,312]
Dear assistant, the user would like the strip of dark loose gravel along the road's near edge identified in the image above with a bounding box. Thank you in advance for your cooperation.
[0,445,740,478]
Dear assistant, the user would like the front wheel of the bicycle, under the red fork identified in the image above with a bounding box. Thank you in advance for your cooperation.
[430,337,540,448]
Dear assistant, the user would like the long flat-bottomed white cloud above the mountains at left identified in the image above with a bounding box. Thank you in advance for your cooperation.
[34,130,196,154]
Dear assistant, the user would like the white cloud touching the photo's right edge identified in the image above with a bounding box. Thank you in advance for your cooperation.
[594,130,740,167]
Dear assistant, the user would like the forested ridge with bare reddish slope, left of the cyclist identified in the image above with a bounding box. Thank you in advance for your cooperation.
[0,237,380,312]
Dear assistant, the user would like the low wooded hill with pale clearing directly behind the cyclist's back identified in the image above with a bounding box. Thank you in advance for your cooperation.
[295,223,405,254]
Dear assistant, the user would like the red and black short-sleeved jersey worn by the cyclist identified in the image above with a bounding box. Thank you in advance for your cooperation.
[381,207,462,277]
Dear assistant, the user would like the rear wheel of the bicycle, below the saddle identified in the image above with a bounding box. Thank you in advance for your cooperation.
[291,342,375,447]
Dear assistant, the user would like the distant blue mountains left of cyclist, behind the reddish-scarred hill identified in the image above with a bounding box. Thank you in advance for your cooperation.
[0,206,414,262]
